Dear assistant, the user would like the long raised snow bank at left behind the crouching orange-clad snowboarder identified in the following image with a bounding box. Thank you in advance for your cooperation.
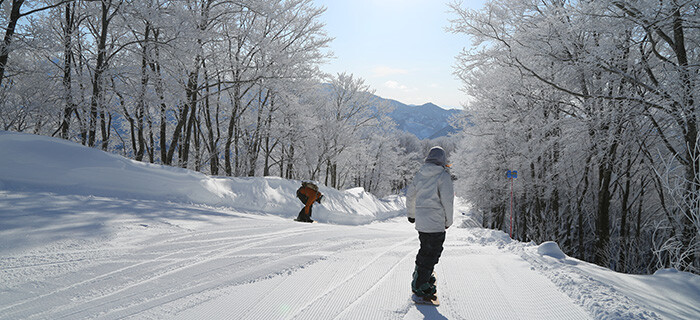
[0,131,405,225]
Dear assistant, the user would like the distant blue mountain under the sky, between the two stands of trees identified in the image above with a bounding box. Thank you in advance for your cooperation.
[377,97,460,140]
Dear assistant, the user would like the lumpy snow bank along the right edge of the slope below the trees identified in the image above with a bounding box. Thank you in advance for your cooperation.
[448,224,700,319]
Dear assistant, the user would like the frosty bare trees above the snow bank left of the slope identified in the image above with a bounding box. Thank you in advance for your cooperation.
[0,0,448,195]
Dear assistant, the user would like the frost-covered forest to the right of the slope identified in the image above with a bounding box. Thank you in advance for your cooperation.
[449,0,700,273]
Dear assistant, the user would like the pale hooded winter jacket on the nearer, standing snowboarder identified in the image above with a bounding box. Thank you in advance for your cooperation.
[406,149,454,233]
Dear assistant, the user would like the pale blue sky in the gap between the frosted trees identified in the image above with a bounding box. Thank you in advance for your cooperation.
[314,0,485,108]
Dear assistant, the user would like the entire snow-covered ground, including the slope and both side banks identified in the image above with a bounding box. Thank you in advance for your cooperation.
[0,132,700,319]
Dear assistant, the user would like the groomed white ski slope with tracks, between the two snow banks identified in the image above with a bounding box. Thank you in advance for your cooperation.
[0,192,589,319]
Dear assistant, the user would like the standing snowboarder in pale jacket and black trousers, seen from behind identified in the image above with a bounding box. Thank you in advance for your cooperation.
[406,147,454,304]
